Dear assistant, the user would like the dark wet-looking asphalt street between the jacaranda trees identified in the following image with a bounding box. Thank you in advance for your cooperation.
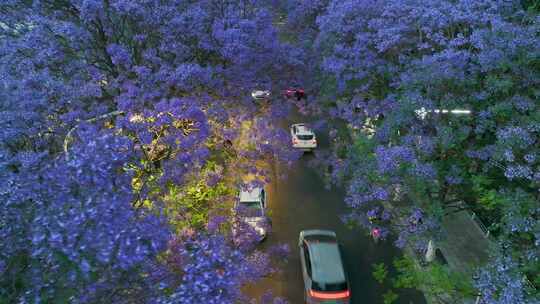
[249,111,425,304]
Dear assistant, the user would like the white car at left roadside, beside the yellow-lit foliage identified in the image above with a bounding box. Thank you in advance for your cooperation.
[232,187,270,241]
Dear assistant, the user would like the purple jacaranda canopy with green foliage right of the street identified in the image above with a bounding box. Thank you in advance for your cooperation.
[284,0,540,303]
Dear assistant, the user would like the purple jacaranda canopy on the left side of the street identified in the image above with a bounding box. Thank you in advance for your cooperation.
[0,0,298,303]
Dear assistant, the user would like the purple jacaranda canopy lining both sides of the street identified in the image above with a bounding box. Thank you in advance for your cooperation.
[0,0,540,304]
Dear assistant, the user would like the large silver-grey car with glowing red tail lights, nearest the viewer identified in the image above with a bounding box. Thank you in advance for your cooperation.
[298,230,351,304]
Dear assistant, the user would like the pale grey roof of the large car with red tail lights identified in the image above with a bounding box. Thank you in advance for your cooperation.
[307,241,345,283]
